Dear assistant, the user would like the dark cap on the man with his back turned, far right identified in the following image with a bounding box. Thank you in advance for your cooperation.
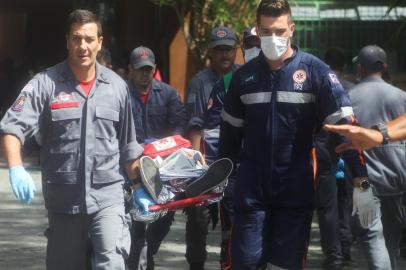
[352,45,386,69]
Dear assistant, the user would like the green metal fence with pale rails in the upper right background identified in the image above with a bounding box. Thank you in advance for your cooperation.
[291,0,406,73]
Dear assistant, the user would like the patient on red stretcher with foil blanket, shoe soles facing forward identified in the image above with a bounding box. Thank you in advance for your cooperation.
[126,136,233,222]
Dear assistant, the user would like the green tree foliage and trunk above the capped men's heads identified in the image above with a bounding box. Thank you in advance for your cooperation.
[150,0,259,66]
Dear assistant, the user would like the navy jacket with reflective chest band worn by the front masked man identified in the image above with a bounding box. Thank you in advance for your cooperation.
[219,47,366,207]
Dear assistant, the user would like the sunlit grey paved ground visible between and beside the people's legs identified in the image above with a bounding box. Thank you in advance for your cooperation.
[0,165,406,270]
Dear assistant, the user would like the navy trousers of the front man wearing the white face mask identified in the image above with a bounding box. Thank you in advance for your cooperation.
[231,206,313,270]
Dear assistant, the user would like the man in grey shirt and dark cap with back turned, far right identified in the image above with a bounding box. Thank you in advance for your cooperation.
[350,45,406,269]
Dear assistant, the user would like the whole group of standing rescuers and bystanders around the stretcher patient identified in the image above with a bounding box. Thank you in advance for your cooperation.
[0,0,406,270]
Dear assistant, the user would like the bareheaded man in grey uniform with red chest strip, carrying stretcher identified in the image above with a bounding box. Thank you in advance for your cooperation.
[0,10,148,270]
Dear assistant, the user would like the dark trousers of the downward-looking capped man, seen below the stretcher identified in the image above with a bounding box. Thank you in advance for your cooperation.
[127,211,175,270]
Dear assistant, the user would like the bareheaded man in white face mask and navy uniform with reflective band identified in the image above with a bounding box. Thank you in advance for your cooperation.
[219,0,379,270]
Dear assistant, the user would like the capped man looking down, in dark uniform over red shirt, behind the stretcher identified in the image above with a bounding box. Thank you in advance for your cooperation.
[128,47,186,270]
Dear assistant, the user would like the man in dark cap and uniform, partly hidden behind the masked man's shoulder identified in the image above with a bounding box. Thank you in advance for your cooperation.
[186,27,238,270]
